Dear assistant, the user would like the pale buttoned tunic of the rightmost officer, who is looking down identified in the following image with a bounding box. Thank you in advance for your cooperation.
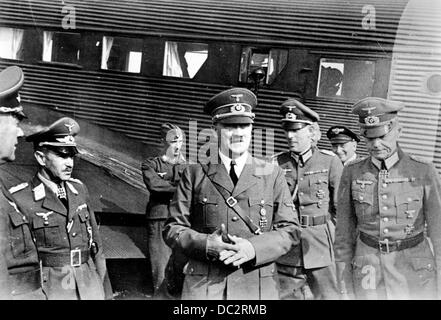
[335,149,441,299]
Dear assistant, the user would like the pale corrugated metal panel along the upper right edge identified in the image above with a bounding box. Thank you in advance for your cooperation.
[388,0,441,170]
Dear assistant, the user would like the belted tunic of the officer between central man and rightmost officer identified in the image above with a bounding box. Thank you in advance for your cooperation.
[277,148,343,269]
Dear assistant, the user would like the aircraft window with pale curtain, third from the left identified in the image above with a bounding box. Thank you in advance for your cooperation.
[101,36,142,73]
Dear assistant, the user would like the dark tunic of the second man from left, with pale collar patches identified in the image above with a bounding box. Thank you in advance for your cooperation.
[13,175,111,300]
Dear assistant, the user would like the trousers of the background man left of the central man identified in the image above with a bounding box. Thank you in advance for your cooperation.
[147,219,171,299]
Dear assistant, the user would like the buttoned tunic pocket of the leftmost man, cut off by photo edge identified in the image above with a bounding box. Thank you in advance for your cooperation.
[8,211,35,258]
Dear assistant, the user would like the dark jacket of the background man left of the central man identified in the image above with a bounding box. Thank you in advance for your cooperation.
[141,157,185,219]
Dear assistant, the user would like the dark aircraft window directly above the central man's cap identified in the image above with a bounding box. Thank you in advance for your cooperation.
[239,47,288,85]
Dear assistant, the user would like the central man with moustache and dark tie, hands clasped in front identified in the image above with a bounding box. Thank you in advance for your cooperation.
[164,88,299,300]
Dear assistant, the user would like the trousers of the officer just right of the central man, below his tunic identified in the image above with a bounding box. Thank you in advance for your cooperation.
[277,264,340,300]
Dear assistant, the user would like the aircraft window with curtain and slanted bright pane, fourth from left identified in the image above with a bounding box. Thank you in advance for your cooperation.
[162,41,208,79]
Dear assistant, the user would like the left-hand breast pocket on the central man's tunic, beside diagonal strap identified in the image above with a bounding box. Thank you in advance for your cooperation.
[194,195,218,232]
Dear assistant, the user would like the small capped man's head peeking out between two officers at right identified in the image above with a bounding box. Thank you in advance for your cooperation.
[326,126,360,165]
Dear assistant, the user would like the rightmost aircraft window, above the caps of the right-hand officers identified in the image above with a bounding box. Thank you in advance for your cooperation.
[317,58,375,99]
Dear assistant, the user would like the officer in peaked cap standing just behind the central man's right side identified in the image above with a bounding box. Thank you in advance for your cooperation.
[276,99,342,299]
